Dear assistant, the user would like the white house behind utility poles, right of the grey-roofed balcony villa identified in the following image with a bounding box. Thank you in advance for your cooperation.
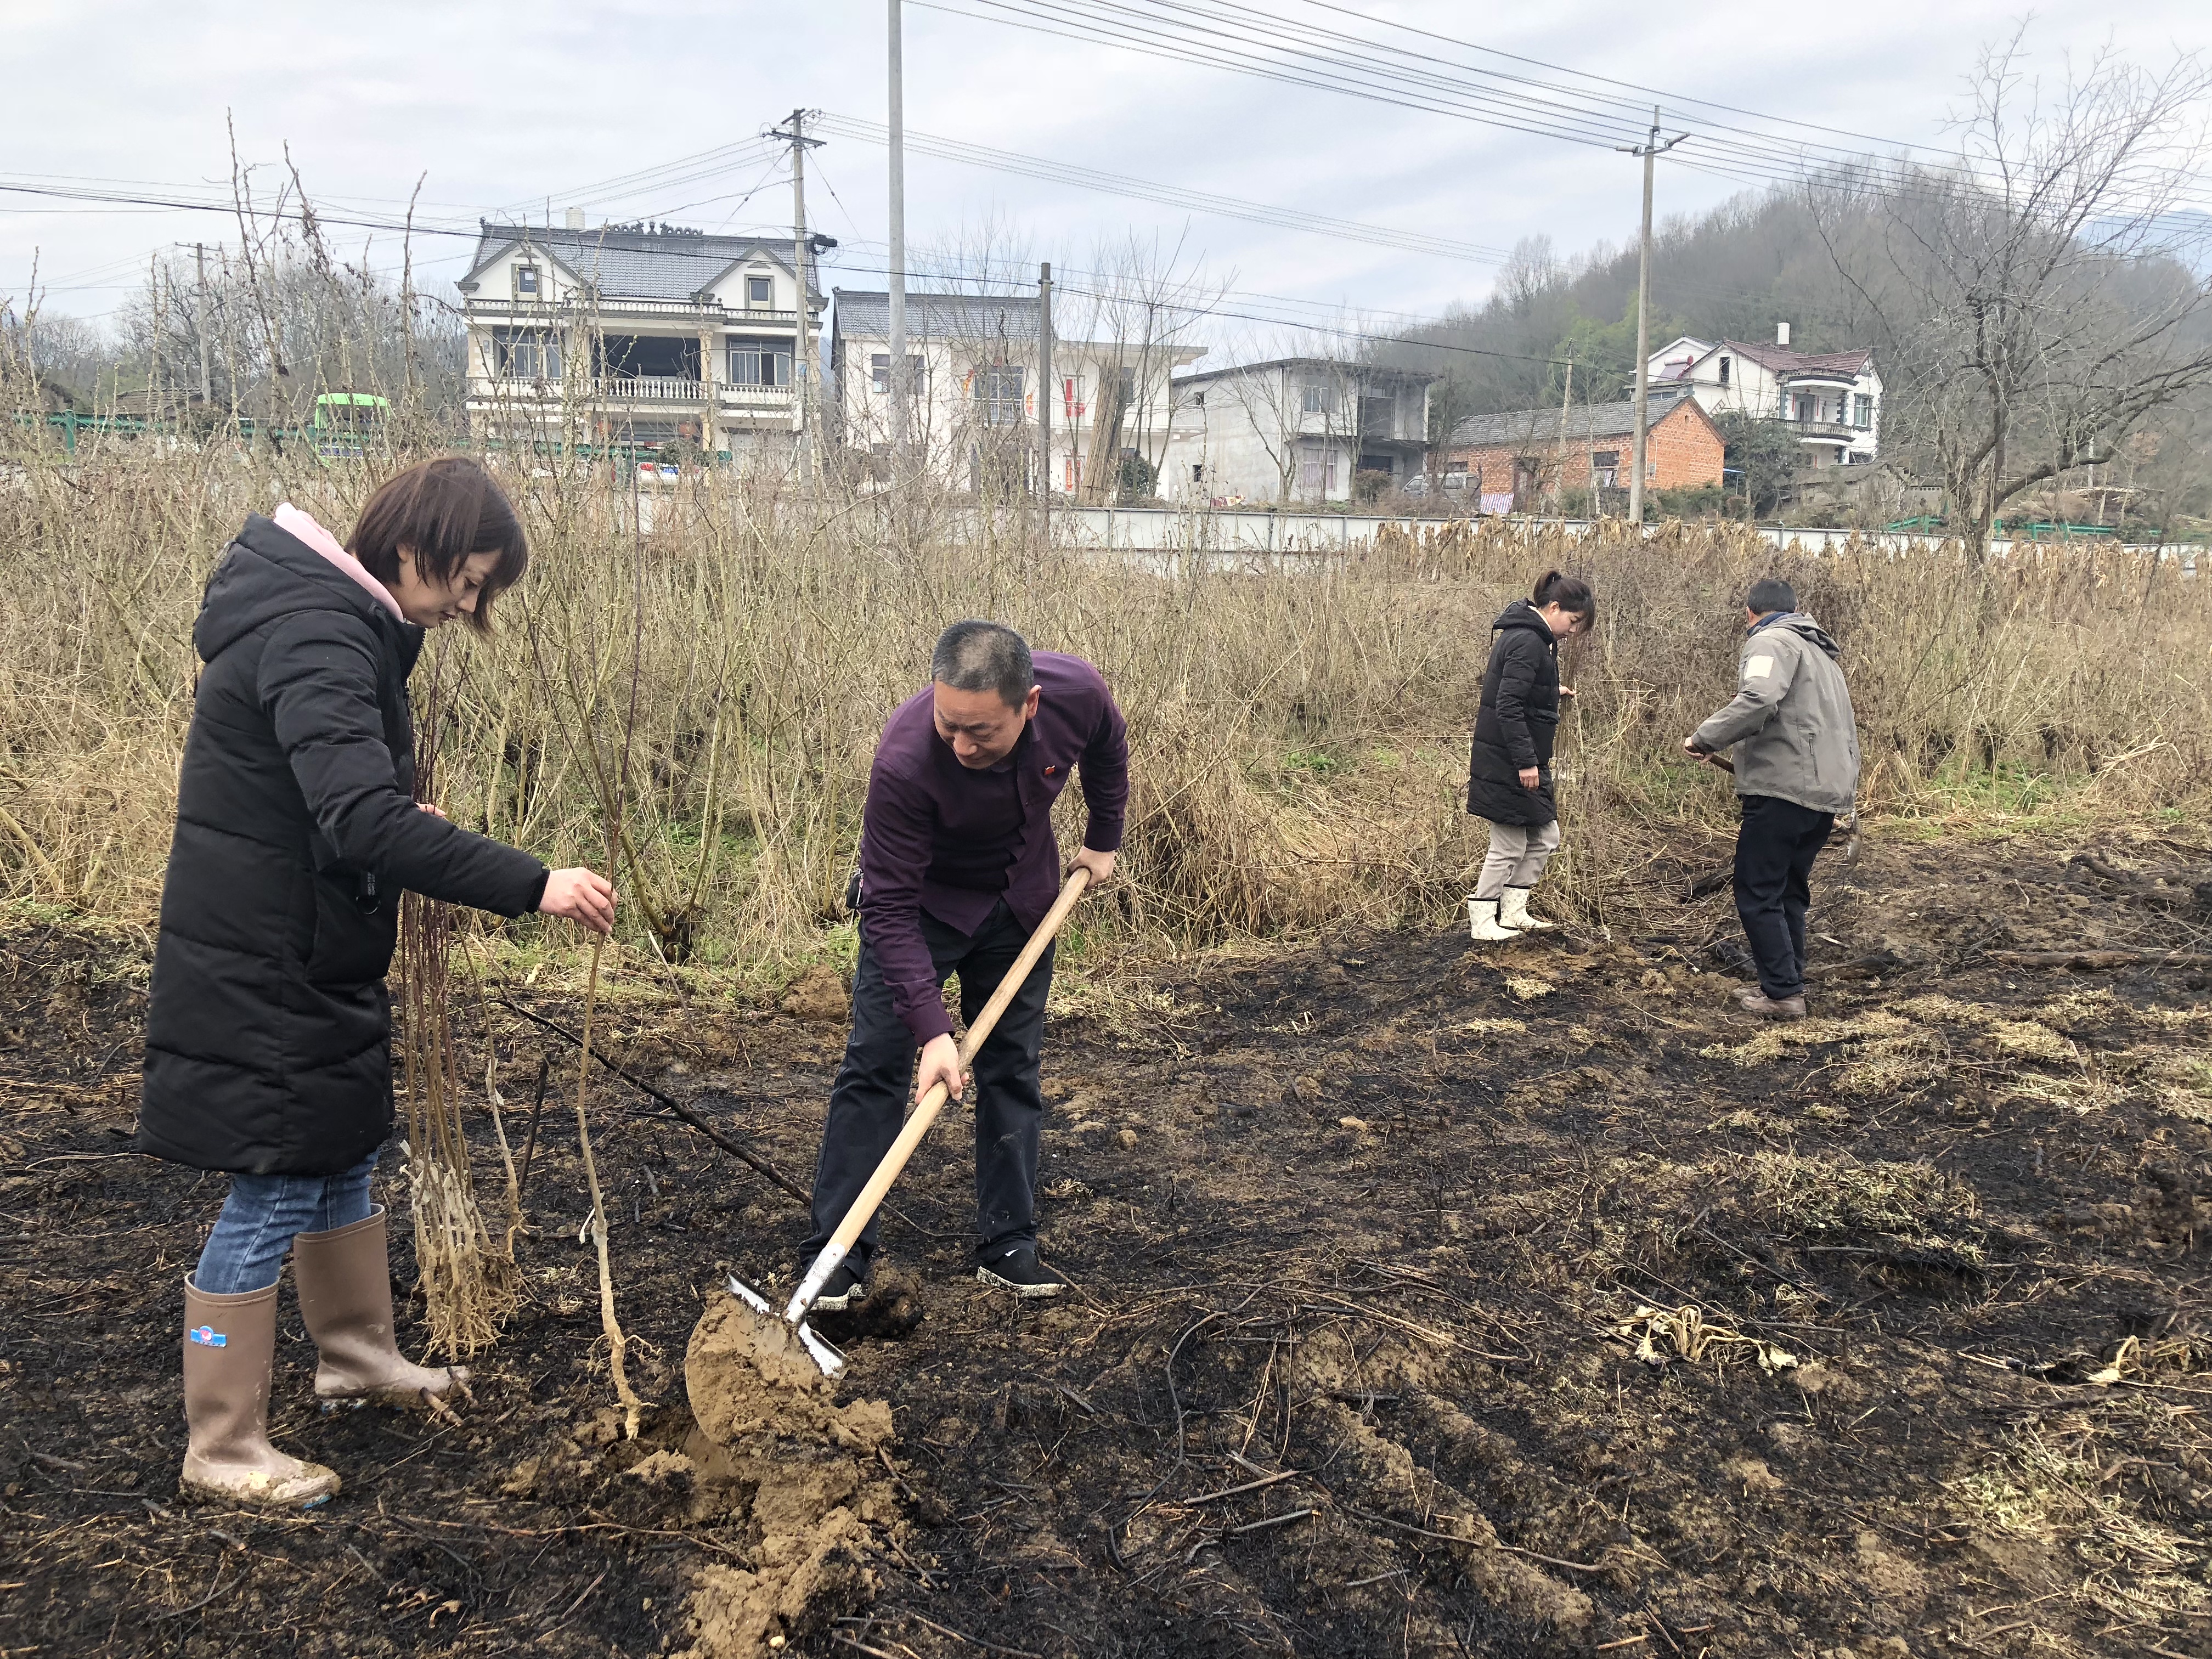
[830,287,1205,500]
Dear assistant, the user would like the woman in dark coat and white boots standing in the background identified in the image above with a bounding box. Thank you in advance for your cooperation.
[1466,571,1597,940]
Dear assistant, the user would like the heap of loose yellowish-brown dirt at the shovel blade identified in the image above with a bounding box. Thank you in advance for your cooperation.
[684,1294,900,1659]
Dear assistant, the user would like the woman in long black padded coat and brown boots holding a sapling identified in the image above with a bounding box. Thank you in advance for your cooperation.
[139,460,615,1506]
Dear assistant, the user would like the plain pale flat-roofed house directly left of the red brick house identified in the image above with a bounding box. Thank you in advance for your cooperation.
[1159,356,1438,506]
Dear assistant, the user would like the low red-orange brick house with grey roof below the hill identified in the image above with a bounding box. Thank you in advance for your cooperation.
[1434,394,1725,513]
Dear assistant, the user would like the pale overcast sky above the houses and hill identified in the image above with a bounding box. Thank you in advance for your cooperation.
[0,0,2212,352]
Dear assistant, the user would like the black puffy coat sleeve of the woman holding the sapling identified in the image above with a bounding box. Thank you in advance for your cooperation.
[259,611,546,916]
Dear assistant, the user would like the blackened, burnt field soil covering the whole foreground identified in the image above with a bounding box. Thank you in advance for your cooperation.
[0,830,2212,1659]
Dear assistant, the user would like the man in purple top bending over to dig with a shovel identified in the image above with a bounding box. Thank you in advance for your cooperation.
[808,622,1128,1312]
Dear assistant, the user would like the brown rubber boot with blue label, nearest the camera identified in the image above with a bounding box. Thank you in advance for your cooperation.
[177,1276,338,1509]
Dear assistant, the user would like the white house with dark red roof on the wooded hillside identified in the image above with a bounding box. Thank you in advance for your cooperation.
[1646,323,1882,467]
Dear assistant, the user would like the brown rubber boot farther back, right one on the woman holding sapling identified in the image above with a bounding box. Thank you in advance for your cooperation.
[292,1205,471,1411]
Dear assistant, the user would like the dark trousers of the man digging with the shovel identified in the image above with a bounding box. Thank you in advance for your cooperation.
[808,900,1053,1265]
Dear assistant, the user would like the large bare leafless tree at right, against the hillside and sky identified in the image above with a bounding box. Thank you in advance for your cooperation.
[1812,33,2212,553]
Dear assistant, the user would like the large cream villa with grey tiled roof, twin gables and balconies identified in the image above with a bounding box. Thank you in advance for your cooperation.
[458,210,821,456]
